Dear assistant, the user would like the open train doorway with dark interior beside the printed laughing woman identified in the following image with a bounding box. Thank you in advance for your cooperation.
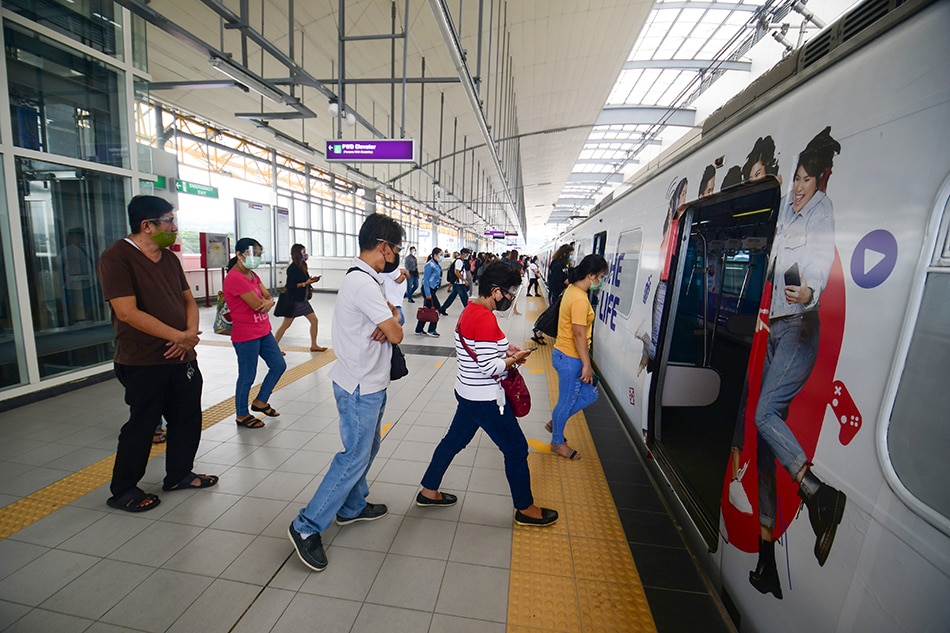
[648,179,781,547]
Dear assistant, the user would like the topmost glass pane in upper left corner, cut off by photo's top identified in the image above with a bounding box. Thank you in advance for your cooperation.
[3,0,122,58]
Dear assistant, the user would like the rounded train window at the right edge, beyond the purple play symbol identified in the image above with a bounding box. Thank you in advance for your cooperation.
[887,196,950,525]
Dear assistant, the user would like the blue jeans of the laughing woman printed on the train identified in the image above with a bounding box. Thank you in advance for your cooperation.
[755,312,819,528]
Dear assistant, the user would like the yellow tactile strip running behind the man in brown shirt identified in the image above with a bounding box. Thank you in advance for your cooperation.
[0,341,336,540]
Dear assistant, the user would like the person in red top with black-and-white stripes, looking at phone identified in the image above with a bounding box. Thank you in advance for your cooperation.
[416,262,558,526]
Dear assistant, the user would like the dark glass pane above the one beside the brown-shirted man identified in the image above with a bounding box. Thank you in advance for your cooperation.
[3,23,129,167]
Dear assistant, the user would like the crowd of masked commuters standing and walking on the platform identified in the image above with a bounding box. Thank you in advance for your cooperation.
[97,196,607,571]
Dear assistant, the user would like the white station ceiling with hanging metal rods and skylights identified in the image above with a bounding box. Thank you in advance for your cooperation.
[118,0,840,239]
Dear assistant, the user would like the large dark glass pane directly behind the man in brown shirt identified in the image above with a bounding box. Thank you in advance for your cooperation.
[16,158,128,377]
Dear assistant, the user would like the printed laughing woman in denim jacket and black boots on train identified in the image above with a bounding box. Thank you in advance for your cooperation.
[749,127,846,598]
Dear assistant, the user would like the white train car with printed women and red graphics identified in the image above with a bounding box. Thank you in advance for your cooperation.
[554,0,950,633]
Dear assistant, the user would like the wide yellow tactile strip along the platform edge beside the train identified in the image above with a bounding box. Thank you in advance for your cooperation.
[508,300,656,633]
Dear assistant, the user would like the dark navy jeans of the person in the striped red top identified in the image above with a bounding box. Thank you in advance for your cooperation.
[422,392,534,510]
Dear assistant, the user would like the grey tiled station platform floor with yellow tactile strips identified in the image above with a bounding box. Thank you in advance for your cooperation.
[0,290,734,633]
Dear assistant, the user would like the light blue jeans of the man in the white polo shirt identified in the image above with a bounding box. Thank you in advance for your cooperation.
[294,383,386,534]
